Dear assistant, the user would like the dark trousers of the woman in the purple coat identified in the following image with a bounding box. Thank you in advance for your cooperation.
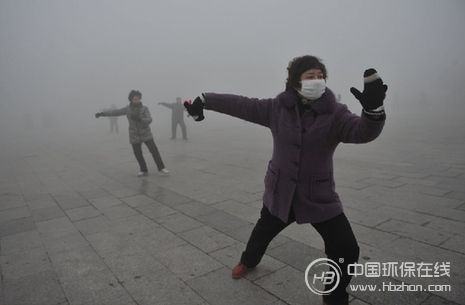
[241,207,360,305]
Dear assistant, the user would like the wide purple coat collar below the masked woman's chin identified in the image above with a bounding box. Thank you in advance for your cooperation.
[278,88,336,114]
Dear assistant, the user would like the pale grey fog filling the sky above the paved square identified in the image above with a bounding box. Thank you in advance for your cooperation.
[0,0,465,137]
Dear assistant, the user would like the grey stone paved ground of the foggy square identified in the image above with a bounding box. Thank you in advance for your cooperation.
[0,110,465,305]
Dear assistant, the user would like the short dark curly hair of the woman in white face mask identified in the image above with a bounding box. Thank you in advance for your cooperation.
[286,55,328,89]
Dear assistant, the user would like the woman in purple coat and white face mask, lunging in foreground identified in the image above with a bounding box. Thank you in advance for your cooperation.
[185,55,387,305]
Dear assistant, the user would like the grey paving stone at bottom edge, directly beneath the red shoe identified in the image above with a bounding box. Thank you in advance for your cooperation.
[187,268,277,305]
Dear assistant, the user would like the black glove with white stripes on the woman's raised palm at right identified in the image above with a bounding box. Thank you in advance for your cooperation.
[350,68,387,111]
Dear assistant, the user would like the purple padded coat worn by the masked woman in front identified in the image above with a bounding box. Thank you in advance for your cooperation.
[204,89,385,223]
